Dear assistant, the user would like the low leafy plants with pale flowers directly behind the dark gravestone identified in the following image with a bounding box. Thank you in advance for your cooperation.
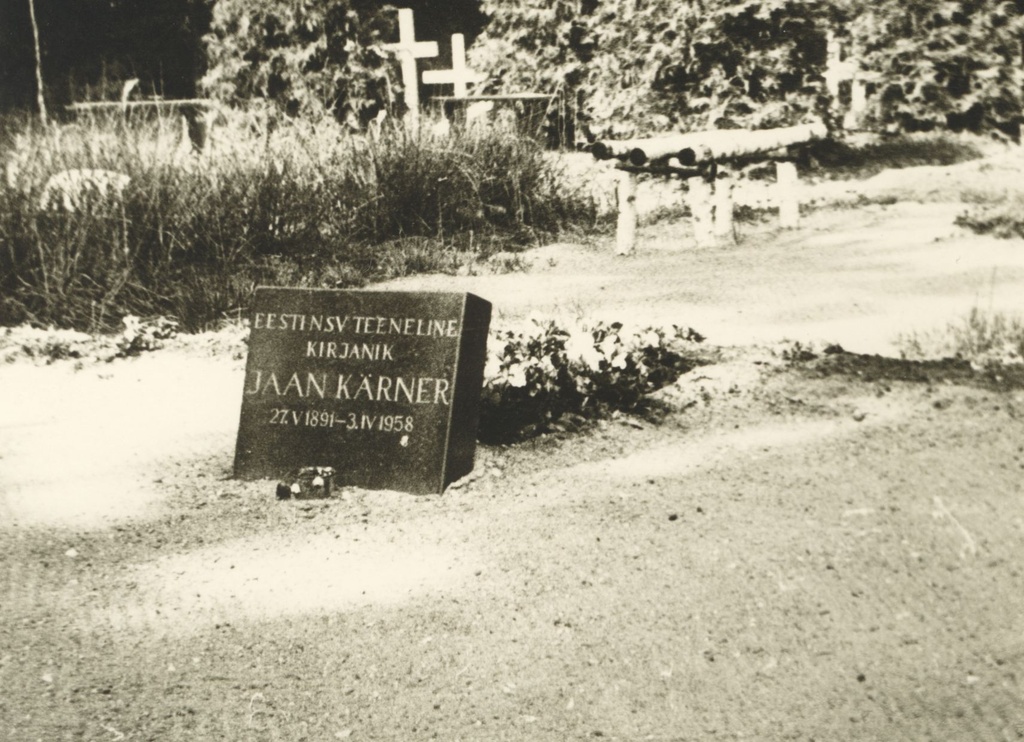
[478,320,703,442]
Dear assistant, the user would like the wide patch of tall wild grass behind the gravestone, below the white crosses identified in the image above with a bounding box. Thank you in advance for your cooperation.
[0,112,594,332]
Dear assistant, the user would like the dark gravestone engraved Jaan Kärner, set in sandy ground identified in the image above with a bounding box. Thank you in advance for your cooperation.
[234,288,490,494]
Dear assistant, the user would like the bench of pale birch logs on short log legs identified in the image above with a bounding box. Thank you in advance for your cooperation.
[591,122,828,255]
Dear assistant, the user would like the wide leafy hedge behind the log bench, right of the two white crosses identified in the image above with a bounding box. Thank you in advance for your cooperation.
[473,0,1024,136]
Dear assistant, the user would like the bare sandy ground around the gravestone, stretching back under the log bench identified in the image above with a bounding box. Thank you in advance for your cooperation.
[0,151,1024,742]
